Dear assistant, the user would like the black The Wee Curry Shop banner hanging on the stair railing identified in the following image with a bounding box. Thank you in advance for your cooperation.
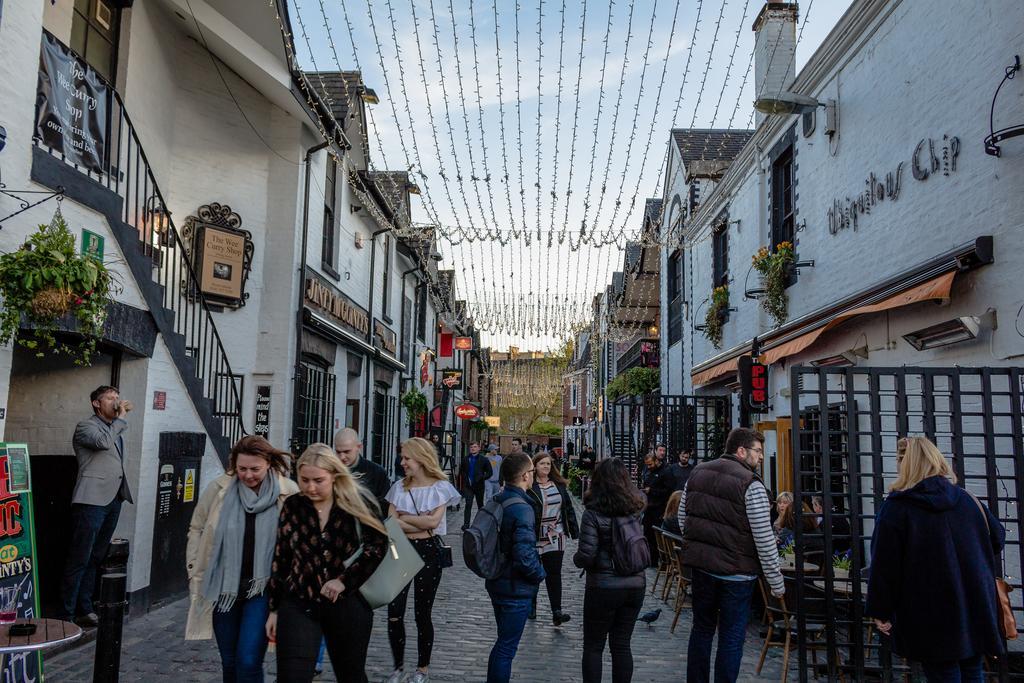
[36,31,111,173]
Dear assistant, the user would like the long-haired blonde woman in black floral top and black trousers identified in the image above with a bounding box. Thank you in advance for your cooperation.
[266,443,387,683]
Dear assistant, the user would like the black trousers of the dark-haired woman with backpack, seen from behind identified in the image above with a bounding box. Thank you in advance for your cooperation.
[583,587,645,683]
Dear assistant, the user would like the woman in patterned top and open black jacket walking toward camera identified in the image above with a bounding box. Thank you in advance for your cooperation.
[530,451,580,626]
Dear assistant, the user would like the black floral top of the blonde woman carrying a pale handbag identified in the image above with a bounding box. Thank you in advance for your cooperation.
[267,494,387,610]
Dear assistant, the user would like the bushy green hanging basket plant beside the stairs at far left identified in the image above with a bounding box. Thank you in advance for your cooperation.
[0,211,115,366]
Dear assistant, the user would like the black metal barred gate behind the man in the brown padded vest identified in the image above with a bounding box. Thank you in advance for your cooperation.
[607,394,732,481]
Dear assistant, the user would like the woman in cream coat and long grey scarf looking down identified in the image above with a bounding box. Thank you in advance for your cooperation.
[185,436,298,683]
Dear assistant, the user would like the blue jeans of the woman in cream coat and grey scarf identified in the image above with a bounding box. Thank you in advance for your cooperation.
[213,595,270,683]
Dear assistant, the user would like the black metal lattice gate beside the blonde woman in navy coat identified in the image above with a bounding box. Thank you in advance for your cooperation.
[791,367,1024,681]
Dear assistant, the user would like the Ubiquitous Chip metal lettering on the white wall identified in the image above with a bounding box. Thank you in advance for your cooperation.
[825,135,961,234]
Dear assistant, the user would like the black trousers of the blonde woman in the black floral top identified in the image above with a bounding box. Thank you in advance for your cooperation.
[278,592,374,683]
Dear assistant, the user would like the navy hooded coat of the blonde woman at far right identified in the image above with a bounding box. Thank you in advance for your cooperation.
[864,476,1006,661]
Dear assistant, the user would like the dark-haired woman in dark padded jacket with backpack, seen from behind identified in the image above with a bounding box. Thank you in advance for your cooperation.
[572,458,647,683]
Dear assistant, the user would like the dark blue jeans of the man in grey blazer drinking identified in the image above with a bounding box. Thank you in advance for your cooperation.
[60,497,121,618]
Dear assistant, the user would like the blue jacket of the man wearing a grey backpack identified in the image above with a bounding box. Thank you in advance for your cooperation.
[485,486,545,598]
